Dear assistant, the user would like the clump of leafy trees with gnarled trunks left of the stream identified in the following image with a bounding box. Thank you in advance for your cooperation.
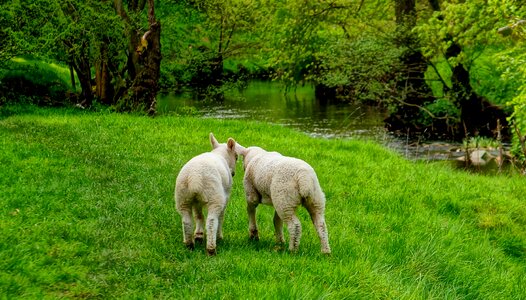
[0,0,161,114]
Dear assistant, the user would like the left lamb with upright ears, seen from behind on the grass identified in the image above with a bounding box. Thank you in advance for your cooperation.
[175,133,237,255]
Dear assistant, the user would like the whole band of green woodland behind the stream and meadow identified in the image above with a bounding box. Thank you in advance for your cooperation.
[0,0,526,161]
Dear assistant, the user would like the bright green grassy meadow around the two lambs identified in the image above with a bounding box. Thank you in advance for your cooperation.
[0,107,526,299]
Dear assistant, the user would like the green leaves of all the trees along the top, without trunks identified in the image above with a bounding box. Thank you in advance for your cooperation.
[0,0,526,144]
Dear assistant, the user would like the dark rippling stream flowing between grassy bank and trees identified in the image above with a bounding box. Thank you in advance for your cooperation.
[158,81,510,171]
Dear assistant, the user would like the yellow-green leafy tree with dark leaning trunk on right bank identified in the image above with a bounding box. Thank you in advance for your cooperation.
[417,0,516,137]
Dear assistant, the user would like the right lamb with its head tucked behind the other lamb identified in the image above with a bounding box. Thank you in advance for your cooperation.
[236,146,331,253]
